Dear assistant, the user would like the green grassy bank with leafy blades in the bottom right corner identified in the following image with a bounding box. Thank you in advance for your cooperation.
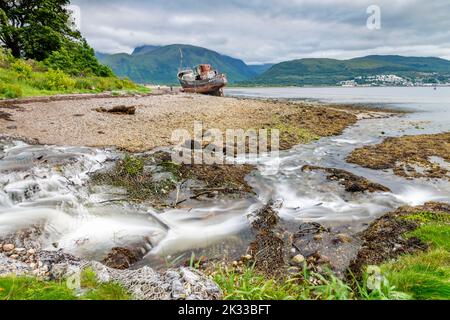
[211,206,450,300]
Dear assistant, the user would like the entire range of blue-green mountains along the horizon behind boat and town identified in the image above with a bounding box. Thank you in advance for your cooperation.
[97,44,450,86]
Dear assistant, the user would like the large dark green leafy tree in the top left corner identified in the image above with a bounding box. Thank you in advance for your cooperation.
[0,0,82,61]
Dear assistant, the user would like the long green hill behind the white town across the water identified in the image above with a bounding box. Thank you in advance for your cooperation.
[249,55,450,85]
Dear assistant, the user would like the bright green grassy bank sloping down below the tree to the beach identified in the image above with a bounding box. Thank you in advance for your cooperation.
[0,50,149,99]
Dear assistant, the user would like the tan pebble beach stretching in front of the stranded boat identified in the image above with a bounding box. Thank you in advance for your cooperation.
[0,94,367,152]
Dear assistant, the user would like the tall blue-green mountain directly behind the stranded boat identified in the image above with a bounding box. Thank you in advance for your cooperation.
[97,44,257,84]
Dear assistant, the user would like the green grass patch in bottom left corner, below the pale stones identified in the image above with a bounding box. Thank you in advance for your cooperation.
[0,269,131,300]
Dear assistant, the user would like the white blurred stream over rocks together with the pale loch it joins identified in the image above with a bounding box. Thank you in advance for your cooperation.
[0,88,450,265]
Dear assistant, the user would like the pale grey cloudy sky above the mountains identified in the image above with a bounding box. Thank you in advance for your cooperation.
[71,0,450,64]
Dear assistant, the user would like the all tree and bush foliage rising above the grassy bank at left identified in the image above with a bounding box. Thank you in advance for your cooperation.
[0,0,112,76]
